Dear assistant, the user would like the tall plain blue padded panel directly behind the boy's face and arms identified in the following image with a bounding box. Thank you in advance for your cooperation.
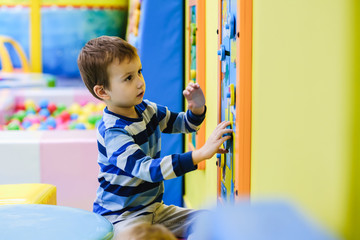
[137,0,184,206]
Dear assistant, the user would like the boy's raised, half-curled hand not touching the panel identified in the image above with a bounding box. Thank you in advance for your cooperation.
[183,82,205,115]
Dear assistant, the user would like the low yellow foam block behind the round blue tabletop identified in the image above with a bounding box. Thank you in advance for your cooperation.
[0,183,56,205]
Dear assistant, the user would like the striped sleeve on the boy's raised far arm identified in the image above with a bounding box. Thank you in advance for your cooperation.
[148,101,206,133]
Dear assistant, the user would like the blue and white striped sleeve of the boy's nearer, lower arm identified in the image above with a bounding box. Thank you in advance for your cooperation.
[104,128,197,182]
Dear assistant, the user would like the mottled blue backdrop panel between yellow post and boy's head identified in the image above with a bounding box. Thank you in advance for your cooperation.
[41,8,127,77]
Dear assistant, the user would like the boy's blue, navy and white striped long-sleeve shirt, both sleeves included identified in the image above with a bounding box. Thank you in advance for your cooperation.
[93,100,205,218]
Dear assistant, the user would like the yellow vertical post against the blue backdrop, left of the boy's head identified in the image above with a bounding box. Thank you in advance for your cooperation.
[30,0,42,72]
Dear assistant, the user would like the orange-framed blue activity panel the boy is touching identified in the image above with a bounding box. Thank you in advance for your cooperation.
[217,0,252,202]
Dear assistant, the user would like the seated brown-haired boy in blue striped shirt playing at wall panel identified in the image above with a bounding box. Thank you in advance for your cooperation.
[78,36,232,237]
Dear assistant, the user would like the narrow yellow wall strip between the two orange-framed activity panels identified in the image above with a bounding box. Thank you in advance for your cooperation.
[184,0,218,208]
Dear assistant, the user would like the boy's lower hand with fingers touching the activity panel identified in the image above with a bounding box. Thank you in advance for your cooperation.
[192,121,233,165]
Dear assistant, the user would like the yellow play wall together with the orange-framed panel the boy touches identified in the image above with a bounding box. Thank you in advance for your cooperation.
[184,0,359,239]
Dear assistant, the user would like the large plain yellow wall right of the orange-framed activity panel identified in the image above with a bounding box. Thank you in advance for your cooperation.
[251,0,360,237]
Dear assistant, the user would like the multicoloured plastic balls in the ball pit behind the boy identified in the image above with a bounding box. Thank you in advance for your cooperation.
[0,99,105,131]
